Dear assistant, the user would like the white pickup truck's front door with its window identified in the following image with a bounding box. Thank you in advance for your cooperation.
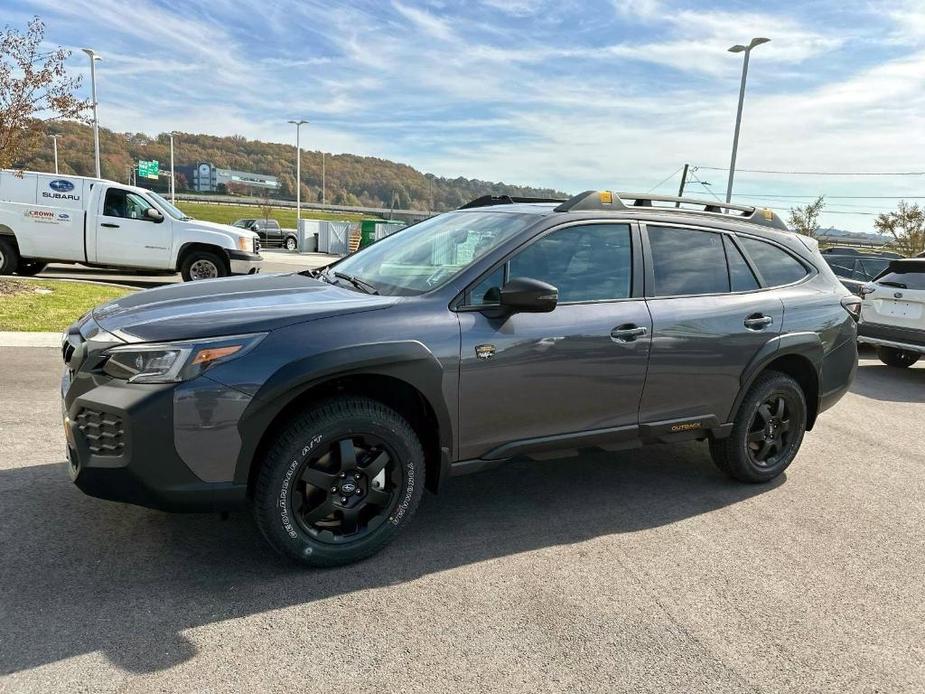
[96,188,172,269]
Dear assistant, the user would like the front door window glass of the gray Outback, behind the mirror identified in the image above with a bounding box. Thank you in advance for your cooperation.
[509,224,632,303]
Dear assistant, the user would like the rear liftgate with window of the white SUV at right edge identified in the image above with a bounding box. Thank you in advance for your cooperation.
[861,259,925,340]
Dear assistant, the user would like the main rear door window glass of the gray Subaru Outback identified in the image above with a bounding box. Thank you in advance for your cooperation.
[648,226,729,296]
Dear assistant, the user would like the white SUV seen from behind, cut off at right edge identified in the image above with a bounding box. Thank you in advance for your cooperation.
[858,258,925,368]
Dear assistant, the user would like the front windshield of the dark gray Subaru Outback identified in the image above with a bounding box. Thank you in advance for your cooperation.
[335,212,536,295]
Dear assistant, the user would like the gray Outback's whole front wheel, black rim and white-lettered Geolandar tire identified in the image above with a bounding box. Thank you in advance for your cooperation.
[253,397,424,566]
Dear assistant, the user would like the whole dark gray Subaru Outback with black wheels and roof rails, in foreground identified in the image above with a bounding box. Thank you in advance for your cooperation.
[61,191,859,566]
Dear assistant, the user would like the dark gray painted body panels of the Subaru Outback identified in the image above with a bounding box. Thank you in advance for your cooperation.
[63,198,856,509]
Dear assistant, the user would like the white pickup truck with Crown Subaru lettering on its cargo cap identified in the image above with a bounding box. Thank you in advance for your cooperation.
[0,171,263,281]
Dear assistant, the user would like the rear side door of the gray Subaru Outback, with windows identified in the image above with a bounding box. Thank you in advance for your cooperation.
[639,223,783,428]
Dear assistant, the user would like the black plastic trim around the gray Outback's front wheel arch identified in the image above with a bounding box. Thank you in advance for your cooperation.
[234,340,456,490]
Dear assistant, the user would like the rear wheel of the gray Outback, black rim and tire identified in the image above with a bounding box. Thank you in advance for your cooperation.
[710,371,806,483]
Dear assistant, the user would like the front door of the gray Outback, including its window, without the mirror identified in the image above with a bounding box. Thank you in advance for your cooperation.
[459,223,651,459]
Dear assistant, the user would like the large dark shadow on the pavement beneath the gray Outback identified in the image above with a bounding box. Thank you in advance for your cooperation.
[0,444,784,675]
